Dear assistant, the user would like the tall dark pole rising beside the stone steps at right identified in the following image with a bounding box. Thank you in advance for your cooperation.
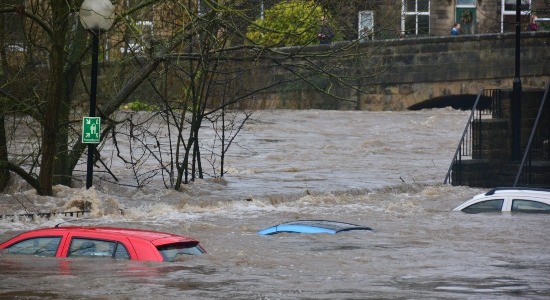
[511,0,522,160]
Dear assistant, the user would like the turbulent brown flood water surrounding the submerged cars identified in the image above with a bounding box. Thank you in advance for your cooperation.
[0,109,550,299]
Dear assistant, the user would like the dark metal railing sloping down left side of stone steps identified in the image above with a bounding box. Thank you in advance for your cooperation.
[444,89,502,185]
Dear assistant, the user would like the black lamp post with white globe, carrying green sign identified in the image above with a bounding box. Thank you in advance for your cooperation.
[79,0,115,189]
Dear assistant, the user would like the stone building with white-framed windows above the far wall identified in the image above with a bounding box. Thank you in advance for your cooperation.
[357,0,550,38]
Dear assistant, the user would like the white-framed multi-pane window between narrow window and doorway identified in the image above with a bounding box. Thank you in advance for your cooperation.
[401,0,430,36]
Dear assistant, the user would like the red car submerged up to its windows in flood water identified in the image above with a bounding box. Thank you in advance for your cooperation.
[0,226,206,261]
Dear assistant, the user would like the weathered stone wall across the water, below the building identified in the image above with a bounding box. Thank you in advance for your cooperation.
[243,32,550,110]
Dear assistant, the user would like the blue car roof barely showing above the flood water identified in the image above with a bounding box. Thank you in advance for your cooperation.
[258,220,372,235]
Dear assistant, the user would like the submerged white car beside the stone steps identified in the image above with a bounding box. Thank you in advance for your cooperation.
[453,187,550,213]
